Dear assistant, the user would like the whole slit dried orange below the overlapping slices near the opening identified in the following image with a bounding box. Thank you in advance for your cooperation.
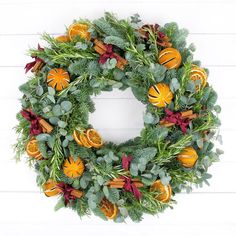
[63,156,84,178]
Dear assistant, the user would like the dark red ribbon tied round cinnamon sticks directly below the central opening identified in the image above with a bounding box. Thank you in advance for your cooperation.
[121,156,142,200]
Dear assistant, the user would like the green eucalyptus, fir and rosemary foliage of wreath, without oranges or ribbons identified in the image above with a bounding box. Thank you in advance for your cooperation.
[15,13,222,222]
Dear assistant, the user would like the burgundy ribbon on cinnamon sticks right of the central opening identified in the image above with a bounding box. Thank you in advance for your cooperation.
[164,108,190,134]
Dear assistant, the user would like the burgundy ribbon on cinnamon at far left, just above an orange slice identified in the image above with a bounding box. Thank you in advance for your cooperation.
[20,110,43,136]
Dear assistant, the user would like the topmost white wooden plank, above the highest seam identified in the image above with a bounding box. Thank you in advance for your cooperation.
[0,0,236,34]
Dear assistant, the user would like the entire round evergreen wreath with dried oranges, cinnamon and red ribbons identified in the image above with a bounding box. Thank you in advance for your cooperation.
[16,13,221,222]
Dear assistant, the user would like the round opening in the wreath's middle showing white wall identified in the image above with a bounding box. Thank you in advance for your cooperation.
[89,89,145,144]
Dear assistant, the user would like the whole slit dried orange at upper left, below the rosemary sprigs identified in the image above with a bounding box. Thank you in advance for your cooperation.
[47,68,70,91]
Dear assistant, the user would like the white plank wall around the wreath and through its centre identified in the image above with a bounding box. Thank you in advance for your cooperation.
[0,0,236,236]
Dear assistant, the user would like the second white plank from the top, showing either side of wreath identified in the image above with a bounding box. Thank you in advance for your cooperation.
[0,34,236,67]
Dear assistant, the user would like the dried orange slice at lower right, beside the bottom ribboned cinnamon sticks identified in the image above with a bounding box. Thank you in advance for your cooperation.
[150,180,172,202]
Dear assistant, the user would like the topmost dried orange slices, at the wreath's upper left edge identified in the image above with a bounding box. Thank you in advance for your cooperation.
[68,23,91,40]
